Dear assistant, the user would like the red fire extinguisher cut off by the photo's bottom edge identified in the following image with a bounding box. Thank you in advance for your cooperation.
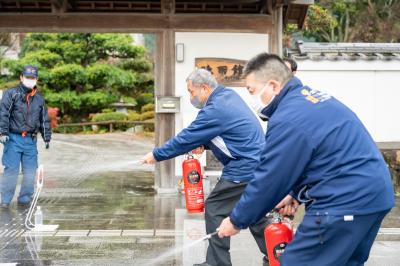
[264,212,293,266]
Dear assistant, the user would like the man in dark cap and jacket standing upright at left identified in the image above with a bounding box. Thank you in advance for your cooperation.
[0,65,51,208]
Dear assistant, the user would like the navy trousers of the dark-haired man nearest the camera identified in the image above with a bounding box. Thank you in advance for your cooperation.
[281,210,390,266]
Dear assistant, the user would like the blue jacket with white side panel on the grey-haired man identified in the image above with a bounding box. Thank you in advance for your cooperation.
[153,86,265,182]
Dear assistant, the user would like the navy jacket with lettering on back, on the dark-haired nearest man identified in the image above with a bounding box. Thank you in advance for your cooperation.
[230,79,394,228]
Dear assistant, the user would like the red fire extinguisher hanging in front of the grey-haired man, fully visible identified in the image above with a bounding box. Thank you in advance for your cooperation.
[182,155,204,212]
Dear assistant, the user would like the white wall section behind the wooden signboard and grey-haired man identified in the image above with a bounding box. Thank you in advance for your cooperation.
[175,32,268,175]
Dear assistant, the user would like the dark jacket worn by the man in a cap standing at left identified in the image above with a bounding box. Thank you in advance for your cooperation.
[0,83,51,141]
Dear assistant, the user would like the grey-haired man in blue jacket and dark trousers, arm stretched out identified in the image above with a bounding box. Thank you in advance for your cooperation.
[143,69,266,266]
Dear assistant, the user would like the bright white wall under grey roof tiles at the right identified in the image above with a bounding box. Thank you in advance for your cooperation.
[297,60,400,142]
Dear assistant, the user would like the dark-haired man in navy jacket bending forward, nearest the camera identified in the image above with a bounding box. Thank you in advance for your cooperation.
[219,54,394,266]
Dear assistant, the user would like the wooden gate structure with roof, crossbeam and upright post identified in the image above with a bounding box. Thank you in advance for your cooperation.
[0,0,314,193]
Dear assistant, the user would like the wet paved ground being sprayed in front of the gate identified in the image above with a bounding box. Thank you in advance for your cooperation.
[0,134,400,266]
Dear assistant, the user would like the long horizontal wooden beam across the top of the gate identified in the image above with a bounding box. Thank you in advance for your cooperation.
[0,13,272,33]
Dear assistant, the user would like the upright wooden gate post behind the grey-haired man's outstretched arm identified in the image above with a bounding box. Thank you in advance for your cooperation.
[154,29,177,193]
